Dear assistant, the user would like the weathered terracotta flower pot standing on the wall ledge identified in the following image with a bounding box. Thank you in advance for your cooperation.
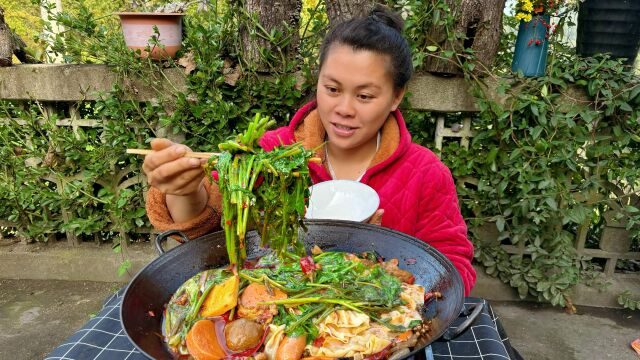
[118,12,184,60]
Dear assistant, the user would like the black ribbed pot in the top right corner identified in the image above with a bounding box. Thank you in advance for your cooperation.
[576,0,640,65]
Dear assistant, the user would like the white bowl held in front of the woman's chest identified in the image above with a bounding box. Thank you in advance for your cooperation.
[305,180,380,222]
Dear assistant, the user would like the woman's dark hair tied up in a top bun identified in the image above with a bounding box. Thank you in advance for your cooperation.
[320,5,413,90]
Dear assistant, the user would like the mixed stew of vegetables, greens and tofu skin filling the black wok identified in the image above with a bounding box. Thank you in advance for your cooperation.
[163,248,438,360]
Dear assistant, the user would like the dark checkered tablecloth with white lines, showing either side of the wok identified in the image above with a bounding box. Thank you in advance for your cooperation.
[45,288,518,360]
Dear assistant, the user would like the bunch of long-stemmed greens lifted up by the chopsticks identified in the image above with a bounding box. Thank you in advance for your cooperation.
[206,114,313,270]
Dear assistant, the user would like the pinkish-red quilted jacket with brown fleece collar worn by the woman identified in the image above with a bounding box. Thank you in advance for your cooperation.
[260,102,476,295]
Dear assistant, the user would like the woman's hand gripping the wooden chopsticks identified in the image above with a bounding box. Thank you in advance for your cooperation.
[142,139,206,196]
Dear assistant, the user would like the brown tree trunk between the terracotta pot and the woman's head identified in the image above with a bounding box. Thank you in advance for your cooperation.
[240,0,302,71]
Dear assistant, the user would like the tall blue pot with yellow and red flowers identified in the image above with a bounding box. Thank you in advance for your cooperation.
[511,0,562,76]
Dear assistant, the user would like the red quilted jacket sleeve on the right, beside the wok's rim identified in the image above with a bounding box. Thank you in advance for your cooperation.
[416,161,476,296]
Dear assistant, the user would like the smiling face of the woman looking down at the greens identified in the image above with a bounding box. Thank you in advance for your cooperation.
[317,44,404,150]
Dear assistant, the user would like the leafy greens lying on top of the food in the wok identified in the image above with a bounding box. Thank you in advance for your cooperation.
[240,252,406,341]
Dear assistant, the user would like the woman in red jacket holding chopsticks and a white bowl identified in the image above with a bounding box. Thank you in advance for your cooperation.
[143,6,476,295]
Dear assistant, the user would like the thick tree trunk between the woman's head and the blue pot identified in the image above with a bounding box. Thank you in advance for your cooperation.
[425,0,505,74]
